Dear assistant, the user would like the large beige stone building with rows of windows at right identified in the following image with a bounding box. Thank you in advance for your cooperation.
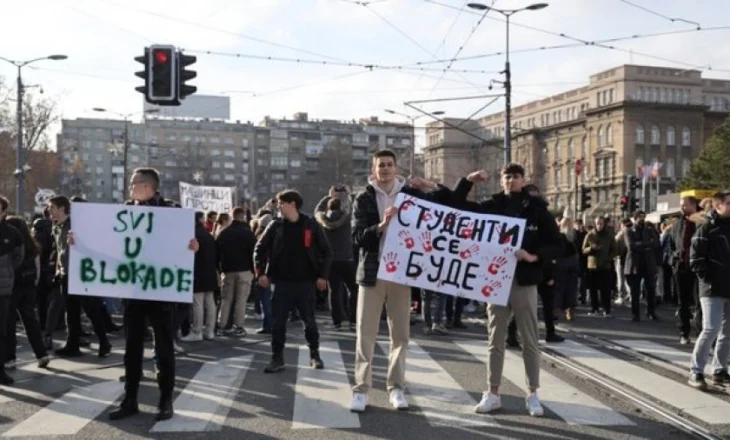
[420,65,730,216]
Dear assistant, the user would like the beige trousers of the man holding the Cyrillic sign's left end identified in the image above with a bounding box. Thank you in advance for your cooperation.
[352,280,411,393]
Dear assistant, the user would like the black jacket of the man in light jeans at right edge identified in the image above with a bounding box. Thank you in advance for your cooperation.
[690,212,730,298]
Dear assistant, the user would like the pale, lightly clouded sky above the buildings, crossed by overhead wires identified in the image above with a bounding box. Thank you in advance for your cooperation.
[0,0,730,150]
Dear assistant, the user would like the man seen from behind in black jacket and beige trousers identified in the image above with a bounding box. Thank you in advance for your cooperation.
[216,206,256,336]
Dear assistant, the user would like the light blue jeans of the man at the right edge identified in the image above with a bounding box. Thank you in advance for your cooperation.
[690,297,730,374]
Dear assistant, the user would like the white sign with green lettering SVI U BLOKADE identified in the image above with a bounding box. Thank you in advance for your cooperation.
[68,203,195,303]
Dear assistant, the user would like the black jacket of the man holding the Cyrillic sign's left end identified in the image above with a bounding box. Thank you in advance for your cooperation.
[352,185,436,286]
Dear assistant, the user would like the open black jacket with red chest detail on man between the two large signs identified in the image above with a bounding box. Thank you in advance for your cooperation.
[253,213,332,280]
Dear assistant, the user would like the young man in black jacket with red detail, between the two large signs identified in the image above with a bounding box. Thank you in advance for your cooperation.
[254,190,332,373]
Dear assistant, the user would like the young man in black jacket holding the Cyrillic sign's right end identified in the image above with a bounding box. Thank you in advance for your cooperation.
[416,163,563,417]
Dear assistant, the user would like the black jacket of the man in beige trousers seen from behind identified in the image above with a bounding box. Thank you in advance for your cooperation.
[215,220,256,273]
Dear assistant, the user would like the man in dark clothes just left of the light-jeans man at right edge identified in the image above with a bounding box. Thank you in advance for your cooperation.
[667,196,699,345]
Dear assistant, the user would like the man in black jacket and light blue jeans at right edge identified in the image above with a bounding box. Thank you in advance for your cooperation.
[689,191,730,390]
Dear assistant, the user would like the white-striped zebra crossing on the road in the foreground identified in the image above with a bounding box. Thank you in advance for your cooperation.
[0,339,730,438]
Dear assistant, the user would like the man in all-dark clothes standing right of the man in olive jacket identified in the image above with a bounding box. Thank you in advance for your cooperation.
[624,211,660,322]
